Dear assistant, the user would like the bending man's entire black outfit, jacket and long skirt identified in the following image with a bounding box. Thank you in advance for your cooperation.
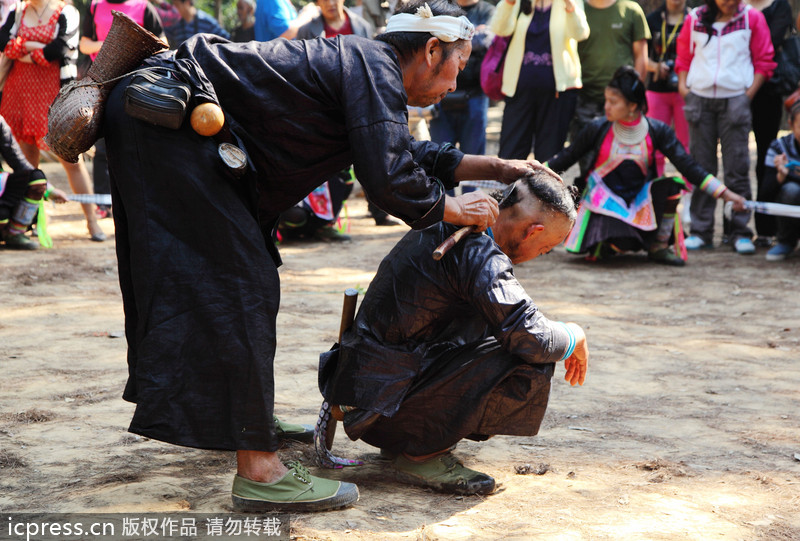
[104,35,463,451]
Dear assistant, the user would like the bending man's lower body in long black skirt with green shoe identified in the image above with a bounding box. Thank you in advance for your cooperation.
[105,83,358,511]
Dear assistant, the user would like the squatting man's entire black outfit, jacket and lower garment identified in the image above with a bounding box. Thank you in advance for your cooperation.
[319,223,569,455]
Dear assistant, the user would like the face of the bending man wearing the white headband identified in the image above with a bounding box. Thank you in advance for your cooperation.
[408,40,472,107]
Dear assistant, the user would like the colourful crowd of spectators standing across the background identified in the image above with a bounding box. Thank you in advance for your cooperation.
[0,0,797,260]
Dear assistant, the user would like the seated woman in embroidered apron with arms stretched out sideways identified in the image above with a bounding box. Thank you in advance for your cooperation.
[547,66,744,266]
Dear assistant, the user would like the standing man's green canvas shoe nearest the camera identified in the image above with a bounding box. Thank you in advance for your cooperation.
[231,461,358,513]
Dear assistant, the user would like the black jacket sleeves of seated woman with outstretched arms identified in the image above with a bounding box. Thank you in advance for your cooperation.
[547,117,709,186]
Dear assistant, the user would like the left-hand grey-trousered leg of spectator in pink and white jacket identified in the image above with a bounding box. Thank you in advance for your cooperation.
[684,94,719,249]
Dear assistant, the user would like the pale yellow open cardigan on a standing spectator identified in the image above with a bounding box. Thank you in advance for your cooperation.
[490,0,589,97]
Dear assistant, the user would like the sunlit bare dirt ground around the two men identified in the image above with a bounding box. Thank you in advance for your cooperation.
[0,116,800,540]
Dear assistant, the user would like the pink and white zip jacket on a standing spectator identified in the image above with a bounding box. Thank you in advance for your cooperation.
[675,4,776,98]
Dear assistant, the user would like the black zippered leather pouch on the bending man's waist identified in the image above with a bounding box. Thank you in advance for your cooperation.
[124,68,192,130]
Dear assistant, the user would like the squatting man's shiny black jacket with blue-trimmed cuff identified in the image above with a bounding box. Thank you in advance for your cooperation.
[319,223,569,416]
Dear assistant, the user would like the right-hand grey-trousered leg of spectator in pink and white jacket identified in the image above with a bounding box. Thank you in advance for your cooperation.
[719,94,754,247]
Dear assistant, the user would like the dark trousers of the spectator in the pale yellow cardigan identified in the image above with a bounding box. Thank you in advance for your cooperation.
[498,86,578,163]
